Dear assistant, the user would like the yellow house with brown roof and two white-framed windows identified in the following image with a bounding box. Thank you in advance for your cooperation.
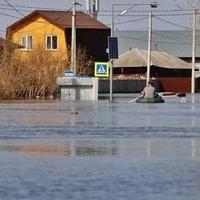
[6,10,110,61]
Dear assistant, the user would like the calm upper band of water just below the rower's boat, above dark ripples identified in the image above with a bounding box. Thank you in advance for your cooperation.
[0,95,200,129]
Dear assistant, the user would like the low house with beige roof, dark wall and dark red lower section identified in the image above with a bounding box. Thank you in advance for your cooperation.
[113,48,191,92]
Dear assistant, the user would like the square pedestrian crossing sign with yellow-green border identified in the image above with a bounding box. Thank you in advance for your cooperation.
[94,62,109,77]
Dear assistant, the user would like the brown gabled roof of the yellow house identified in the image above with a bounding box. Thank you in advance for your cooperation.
[8,10,110,29]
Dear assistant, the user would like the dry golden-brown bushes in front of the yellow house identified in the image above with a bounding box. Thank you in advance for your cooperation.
[0,45,93,99]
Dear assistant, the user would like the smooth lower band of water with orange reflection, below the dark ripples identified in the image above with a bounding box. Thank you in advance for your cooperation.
[0,139,200,160]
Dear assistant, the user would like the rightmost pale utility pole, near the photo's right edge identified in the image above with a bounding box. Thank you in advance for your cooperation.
[191,9,196,94]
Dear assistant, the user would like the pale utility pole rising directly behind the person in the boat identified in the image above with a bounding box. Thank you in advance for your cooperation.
[146,12,152,85]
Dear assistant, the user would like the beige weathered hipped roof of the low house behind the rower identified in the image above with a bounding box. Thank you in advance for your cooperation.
[114,48,191,69]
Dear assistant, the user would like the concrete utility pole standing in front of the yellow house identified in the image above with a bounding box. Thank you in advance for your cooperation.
[71,0,76,76]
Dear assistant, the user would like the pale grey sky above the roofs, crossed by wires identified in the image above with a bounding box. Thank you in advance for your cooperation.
[0,0,200,37]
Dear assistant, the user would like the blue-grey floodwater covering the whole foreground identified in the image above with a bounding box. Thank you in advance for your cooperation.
[0,95,200,200]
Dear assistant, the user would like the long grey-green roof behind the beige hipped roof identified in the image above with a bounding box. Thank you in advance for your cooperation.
[115,30,200,58]
